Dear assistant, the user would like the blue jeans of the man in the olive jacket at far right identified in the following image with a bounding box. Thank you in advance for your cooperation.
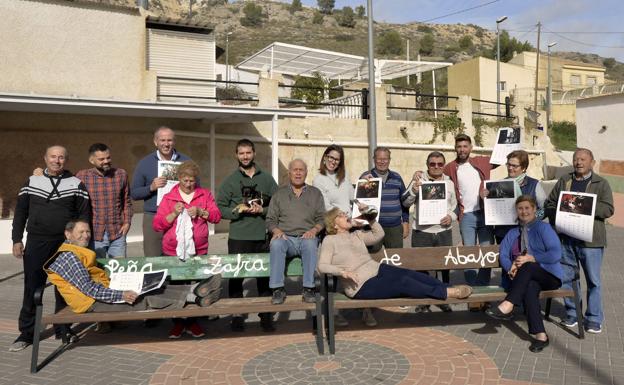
[561,237,604,325]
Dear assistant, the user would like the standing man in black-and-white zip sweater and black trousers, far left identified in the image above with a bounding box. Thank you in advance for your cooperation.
[9,146,91,351]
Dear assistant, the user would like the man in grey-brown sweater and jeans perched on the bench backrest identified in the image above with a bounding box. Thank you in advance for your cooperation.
[266,159,325,305]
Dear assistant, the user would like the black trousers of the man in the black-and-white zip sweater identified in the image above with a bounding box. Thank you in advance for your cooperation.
[17,236,66,343]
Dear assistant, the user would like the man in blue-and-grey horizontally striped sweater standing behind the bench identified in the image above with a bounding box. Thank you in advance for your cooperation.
[360,147,409,248]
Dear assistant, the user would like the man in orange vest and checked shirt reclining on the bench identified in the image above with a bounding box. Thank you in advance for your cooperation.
[43,219,221,320]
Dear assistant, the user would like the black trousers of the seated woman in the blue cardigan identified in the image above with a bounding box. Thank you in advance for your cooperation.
[505,262,561,334]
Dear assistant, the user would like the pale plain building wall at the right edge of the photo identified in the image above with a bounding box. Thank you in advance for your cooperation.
[576,94,624,166]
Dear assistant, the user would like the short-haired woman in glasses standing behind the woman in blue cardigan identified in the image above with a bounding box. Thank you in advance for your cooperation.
[481,150,547,245]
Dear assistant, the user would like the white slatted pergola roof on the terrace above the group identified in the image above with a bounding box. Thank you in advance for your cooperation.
[236,42,452,83]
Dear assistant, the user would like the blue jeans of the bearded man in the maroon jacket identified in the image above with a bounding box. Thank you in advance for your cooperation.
[459,210,493,286]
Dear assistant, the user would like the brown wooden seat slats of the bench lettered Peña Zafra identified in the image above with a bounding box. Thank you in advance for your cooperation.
[42,295,316,325]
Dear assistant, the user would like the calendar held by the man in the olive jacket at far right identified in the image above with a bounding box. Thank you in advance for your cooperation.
[555,191,597,242]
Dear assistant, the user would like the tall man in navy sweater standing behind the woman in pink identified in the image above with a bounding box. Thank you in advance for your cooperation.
[130,126,199,257]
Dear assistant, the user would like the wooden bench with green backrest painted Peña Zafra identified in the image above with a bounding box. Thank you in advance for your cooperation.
[30,253,324,373]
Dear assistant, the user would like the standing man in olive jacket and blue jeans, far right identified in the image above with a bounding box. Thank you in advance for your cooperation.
[544,148,615,334]
